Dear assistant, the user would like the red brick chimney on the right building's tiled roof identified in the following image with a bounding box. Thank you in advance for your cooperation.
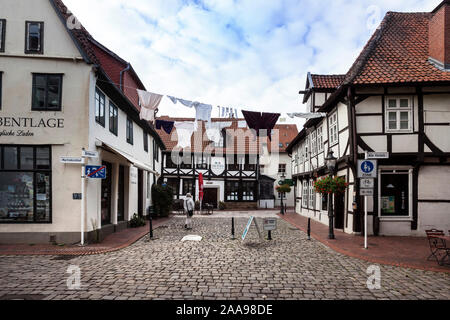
[428,0,450,71]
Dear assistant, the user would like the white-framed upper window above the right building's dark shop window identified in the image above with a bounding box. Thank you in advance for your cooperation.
[386,97,412,132]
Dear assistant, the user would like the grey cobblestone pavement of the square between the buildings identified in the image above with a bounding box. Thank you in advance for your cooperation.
[0,217,450,300]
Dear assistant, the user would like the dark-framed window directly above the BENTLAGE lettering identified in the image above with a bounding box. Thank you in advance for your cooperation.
[31,73,62,111]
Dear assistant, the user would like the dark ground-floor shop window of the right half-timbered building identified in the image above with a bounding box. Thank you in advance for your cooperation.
[380,170,411,218]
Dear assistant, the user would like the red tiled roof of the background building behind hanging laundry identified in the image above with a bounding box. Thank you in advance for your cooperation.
[156,116,298,154]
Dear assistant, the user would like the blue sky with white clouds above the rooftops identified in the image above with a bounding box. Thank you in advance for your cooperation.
[64,0,441,130]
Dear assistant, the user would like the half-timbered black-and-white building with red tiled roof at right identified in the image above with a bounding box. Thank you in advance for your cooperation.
[288,1,450,236]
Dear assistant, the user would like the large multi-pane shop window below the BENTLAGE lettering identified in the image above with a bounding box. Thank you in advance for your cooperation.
[0,146,51,223]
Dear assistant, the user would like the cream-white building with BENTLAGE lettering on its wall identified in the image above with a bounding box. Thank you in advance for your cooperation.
[0,0,164,243]
